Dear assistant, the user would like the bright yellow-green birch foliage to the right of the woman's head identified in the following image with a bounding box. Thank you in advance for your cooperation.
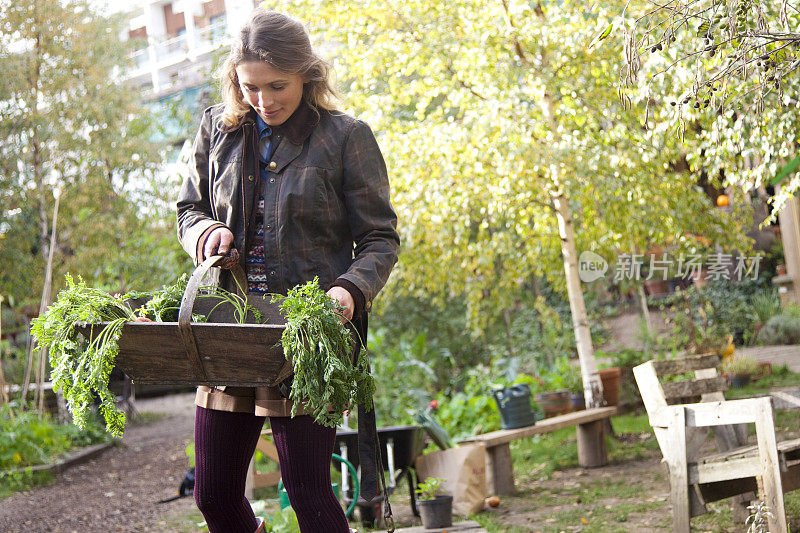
[282,0,745,340]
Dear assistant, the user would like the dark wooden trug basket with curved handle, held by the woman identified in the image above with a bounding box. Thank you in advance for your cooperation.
[87,256,292,387]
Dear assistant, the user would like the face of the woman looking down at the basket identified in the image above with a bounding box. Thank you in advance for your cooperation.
[236,61,303,126]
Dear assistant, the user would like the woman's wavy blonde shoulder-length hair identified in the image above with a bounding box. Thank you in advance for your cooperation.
[217,8,339,127]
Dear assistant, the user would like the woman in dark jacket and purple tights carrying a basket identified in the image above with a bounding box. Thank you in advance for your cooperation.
[177,8,399,533]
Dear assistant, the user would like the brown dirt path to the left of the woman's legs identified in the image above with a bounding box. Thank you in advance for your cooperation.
[0,393,195,533]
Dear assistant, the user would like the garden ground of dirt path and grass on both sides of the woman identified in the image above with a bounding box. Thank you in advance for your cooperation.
[0,376,800,533]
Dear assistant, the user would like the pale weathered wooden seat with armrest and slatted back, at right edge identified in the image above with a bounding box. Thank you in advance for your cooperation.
[633,354,800,533]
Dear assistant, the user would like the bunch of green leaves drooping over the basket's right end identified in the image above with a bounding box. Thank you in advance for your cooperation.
[272,278,375,427]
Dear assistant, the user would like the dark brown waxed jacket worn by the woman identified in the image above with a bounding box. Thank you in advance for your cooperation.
[177,103,400,416]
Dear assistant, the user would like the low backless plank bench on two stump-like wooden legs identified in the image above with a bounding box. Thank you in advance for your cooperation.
[463,407,617,495]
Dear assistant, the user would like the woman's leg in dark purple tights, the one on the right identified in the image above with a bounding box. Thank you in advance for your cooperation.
[269,415,350,533]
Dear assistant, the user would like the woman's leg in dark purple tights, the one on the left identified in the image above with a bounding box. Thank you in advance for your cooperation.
[194,406,265,533]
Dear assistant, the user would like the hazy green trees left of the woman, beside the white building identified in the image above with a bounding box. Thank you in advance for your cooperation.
[0,0,191,305]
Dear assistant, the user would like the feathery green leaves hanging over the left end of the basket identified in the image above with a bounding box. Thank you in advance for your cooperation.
[31,274,136,437]
